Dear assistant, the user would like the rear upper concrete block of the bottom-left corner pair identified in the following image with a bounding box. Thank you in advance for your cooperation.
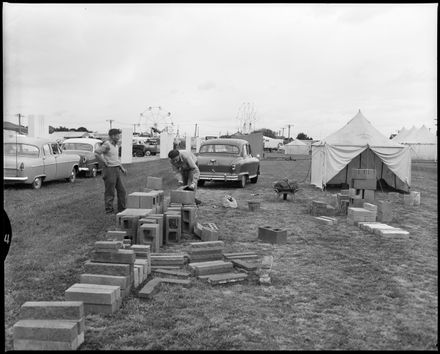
[19,301,84,320]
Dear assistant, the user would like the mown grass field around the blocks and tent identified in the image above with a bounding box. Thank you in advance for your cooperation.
[4,158,438,350]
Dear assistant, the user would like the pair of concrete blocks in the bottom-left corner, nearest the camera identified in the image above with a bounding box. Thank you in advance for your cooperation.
[13,301,85,350]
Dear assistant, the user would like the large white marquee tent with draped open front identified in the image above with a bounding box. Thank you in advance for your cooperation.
[311,110,411,191]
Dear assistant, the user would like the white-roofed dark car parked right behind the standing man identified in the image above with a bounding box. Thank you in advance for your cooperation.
[61,138,102,177]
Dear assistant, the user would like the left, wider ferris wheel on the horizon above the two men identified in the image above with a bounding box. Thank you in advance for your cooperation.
[139,106,174,136]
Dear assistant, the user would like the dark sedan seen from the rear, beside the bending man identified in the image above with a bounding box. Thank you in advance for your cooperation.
[197,139,260,188]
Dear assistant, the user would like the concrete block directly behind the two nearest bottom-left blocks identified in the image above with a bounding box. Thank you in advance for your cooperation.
[64,283,122,314]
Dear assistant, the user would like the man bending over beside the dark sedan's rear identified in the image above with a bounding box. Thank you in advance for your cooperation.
[168,149,200,191]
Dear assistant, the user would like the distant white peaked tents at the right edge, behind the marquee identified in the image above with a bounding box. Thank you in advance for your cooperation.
[393,125,437,161]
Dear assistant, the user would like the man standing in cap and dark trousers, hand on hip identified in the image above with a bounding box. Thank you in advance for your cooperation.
[95,129,127,214]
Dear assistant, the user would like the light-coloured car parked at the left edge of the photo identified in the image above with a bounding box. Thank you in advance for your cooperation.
[3,136,80,189]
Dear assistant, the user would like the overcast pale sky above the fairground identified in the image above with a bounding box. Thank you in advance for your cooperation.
[3,3,437,139]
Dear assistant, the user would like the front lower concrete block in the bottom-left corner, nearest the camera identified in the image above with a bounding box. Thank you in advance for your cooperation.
[13,319,79,342]
